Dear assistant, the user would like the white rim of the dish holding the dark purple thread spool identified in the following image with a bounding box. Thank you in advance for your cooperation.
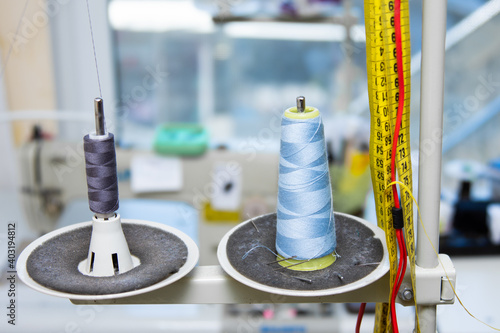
[16,219,200,301]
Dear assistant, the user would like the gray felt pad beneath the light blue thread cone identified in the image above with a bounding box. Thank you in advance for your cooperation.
[226,214,384,290]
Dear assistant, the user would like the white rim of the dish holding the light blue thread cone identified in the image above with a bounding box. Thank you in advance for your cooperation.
[217,213,389,297]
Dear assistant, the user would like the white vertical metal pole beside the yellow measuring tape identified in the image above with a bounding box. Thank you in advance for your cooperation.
[417,0,446,333]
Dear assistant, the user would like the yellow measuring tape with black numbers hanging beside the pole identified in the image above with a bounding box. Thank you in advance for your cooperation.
[364,0,420,332]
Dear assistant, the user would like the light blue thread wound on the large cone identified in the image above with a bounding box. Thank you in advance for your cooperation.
[276,109,337,260]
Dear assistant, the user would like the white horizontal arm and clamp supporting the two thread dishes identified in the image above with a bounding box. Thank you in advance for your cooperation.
[71,254,456,305]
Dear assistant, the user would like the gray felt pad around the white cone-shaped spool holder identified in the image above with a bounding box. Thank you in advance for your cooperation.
[26,223,188,295]
